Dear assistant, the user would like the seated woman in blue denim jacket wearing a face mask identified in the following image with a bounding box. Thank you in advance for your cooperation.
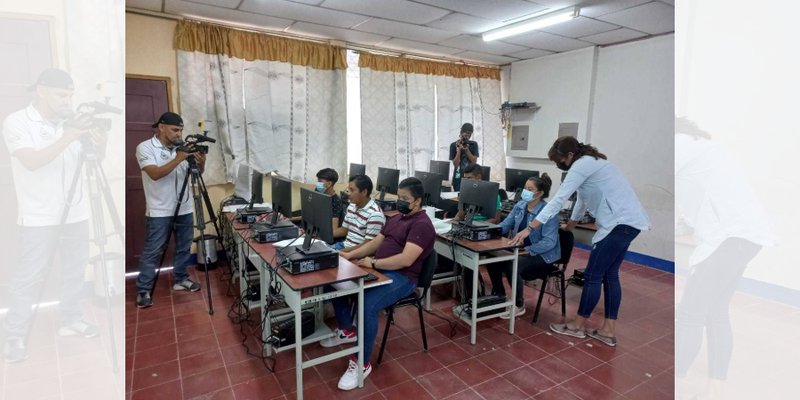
[487,174,561,319]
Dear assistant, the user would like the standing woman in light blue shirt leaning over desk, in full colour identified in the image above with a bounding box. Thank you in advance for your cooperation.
[514,136,650,346]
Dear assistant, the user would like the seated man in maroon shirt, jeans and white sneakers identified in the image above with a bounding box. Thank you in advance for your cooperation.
[320,178,436,390]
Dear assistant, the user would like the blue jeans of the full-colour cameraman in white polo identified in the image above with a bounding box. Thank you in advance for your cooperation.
[136,213,194,292]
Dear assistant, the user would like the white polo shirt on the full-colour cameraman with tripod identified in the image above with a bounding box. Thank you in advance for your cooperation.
[136,136,194,217]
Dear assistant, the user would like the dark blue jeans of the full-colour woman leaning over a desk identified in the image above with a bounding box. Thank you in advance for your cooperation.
[578,225,639,319]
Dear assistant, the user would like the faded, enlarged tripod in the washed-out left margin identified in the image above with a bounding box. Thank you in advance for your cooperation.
[18,134,125,373]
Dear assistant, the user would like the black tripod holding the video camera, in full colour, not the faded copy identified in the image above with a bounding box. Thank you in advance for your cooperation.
[150,152,221,315]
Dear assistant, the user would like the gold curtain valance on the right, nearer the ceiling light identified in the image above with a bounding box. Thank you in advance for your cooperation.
[358,51,500,81]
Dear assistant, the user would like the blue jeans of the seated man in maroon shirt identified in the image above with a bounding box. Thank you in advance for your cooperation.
[332,271,417,363]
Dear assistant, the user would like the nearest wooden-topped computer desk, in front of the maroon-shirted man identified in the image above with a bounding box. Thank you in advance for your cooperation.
[228,211,391,399]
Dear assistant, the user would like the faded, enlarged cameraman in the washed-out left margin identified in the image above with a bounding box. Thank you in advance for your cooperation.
[2,68,106,362]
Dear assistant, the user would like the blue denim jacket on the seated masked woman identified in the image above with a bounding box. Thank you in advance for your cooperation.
[500,200,561,263]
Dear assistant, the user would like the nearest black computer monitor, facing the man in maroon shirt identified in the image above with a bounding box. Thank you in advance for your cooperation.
[298,188,333,255]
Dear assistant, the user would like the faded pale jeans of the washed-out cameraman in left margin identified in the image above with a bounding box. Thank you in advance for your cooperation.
[3,221,89,338]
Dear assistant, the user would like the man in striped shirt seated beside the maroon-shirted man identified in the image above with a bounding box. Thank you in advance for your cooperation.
[334,175,386,251]
